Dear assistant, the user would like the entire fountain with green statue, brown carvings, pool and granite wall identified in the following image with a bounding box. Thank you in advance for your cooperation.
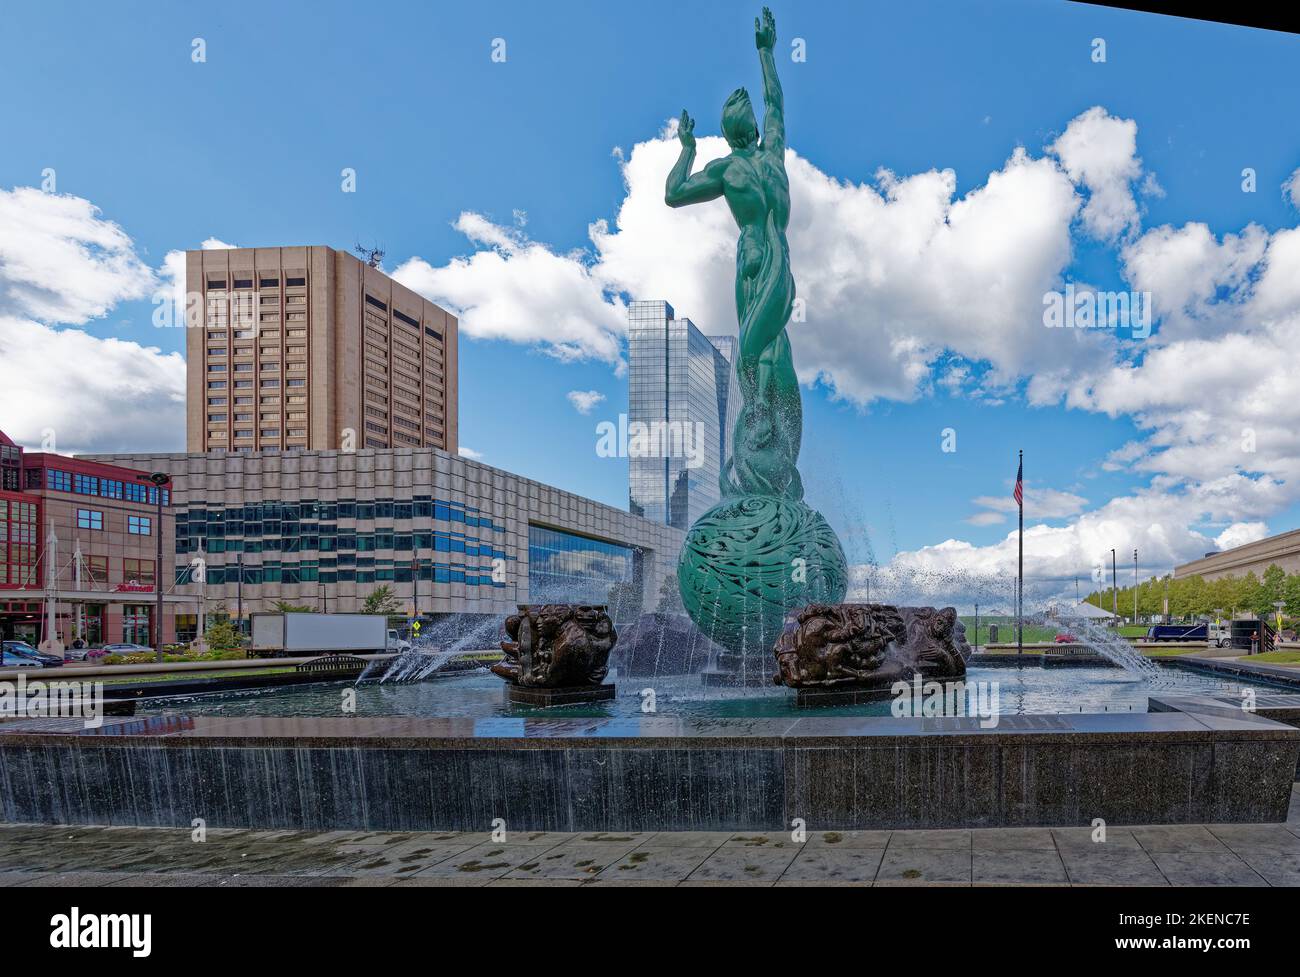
[0,10,1300,831]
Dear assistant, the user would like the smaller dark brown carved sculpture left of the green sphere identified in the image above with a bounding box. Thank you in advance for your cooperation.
[491,604,618,689]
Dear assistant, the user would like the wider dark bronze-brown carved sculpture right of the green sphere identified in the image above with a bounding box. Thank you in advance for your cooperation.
[774,604,971,689]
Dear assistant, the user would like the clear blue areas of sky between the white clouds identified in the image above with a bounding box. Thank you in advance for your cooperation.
[0,0,1300,602]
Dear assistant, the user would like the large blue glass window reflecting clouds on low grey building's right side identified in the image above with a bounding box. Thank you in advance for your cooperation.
[528,525,642,622]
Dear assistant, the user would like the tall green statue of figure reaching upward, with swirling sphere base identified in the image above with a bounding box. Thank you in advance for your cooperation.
[664,8,846,675]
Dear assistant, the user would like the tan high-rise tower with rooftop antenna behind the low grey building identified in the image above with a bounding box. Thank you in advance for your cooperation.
[185,246,458,455]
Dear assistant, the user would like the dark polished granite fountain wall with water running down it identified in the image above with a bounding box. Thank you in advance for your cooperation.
[0,703,1300,831]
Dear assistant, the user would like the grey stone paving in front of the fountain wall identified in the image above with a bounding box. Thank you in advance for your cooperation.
[0,785,1300,887]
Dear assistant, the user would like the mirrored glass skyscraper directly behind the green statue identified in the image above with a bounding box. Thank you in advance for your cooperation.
[628,301,740,530]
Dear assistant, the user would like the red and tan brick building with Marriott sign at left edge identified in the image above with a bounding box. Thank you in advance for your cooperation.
[0,431,189,646]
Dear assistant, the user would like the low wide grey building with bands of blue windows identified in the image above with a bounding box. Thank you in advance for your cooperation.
[94,448,683,622]
